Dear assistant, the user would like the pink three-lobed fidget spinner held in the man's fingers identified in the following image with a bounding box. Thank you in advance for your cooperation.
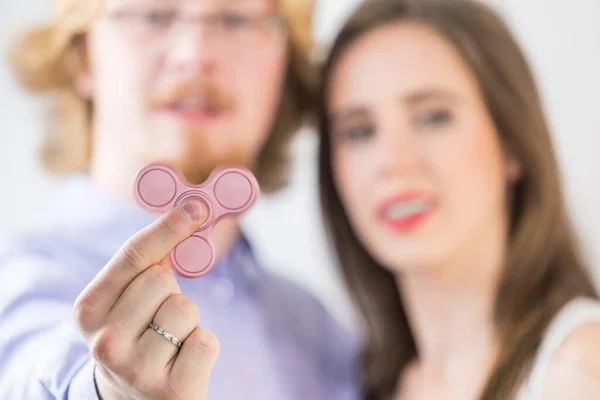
[134,164,260,278]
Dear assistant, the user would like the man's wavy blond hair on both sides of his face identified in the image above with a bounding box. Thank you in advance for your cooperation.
[8,0,314,192]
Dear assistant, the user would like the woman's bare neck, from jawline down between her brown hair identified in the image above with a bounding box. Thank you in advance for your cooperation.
[398,230,505,386]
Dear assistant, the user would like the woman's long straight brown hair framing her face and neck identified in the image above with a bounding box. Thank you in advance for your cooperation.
[319,0,597,400]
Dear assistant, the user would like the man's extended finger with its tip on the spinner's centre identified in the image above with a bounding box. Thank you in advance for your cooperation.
[78,200,208,315]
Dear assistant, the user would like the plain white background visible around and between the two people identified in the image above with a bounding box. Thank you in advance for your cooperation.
[0,0,600,332]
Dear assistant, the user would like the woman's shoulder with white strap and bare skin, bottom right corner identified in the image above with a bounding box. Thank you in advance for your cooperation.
[524,298,600,400]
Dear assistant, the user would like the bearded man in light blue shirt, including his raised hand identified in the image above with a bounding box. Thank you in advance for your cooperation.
[0,0,357,400]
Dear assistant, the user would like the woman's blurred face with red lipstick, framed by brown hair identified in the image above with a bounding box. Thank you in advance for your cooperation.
[327,23,518,272]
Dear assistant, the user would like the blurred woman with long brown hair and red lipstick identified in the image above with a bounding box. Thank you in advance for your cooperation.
[320,0,600,400]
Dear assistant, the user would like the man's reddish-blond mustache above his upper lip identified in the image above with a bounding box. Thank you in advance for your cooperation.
[148,80,235,111]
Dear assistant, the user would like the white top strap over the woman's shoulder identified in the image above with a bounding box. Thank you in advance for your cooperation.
[517,298,600,400]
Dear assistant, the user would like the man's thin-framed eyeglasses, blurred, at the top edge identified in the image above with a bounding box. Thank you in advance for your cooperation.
[106,3,287,57]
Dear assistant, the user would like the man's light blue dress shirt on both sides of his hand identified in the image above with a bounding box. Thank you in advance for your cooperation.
[0,174,359,400]
